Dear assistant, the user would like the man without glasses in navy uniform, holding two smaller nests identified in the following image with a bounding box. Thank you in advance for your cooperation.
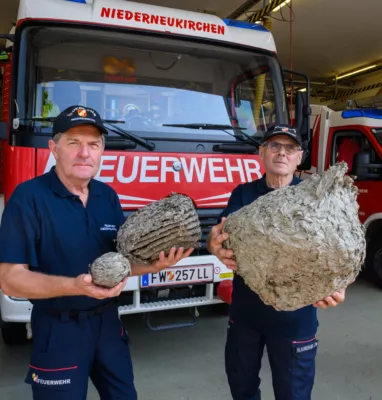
[0,106,192,400]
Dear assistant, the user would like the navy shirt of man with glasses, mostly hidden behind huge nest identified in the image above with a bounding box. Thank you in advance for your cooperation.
[221,175,318,339]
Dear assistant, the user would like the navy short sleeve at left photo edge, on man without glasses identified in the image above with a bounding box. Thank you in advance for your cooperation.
[0,193,39,267]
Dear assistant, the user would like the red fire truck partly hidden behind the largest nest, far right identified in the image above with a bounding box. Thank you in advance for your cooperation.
[298,105,382,287]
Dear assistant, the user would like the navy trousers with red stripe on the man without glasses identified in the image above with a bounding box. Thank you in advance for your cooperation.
[25,307,137,400]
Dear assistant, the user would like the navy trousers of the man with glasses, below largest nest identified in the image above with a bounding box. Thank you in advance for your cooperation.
[225,321,318,400]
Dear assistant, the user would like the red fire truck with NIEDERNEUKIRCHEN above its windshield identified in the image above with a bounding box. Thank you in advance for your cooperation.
[0,0,310,343]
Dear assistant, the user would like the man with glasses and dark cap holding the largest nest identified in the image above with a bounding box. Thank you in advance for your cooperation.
[207,125,345,400]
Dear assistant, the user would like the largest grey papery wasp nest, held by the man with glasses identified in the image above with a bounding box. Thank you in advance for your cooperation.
[223,163,366,311]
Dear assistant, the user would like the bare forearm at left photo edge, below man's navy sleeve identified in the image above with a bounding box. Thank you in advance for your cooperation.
[0,265,79,299]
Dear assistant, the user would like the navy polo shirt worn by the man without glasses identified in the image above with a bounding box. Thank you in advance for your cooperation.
[0,167,124,310]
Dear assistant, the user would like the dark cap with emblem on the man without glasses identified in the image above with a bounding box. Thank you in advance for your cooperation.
[52,106,108,136]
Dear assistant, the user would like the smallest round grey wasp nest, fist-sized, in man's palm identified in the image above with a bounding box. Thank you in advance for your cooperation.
[89,252,131,287]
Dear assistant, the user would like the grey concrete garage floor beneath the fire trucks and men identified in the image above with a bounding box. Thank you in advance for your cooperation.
[0,279,382,400]
